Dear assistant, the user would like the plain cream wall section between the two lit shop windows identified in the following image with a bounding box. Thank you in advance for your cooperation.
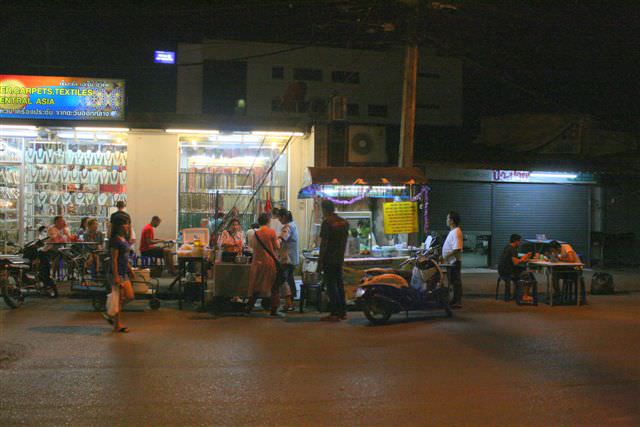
[127,131,179,244]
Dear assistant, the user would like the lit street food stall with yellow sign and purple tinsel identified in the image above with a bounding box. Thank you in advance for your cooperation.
[298,167,429,299]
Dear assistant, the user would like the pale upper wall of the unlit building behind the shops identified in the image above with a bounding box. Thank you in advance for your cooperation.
[177,40,462,126]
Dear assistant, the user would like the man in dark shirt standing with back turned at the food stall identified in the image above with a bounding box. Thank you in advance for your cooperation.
[318,200,349,322]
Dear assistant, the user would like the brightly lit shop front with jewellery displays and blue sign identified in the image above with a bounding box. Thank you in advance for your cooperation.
[0,75,314,251]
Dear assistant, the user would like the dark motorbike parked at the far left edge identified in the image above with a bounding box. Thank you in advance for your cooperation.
[0,237,58,308]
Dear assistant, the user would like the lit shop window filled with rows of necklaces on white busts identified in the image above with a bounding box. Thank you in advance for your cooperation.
[23,128,127,240]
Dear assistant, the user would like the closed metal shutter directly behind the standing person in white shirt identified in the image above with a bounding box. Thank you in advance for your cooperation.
[429,181,491,234]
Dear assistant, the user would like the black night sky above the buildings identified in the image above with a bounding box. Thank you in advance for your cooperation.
[0,0,640,127]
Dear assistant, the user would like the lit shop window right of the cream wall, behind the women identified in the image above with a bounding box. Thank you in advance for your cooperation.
[178,133,289,229]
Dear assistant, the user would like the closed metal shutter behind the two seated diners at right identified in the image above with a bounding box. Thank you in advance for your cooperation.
[491,184,590,264]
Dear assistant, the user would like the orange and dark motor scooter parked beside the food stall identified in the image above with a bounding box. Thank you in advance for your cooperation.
[356,238,453,325]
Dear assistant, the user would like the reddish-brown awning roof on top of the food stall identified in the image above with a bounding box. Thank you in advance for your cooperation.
[309,167,427,185]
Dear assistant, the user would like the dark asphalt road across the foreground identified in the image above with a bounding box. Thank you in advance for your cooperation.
[0,294,640,426]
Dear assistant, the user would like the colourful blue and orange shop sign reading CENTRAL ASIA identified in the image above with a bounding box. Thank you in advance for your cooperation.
[0,74,125,120]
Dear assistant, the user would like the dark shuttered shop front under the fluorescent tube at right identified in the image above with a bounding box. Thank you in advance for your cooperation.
[427,164,597,268]
